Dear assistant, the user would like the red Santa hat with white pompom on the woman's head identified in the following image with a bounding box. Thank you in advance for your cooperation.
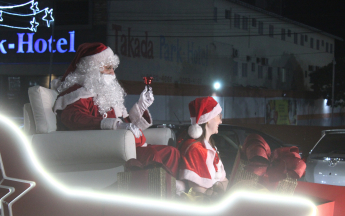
[188,97,222,139]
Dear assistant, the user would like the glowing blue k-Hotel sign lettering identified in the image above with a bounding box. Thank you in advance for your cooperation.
[0,31,75,54]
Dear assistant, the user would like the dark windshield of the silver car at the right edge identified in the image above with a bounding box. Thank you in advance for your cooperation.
[312,134,345,154]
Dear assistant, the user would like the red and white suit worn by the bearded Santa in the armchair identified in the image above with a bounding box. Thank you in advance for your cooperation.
[54,84,180,177]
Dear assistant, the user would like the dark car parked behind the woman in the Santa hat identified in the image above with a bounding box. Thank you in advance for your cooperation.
[152,124,292,174]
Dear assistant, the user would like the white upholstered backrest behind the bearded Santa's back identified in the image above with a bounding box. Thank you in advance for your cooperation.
[24,86,58,134]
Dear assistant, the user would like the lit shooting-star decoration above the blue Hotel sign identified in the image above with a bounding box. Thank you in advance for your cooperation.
[0,0,54,32]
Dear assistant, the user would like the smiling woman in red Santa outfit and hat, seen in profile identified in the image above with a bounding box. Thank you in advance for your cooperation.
[179,97,228,195]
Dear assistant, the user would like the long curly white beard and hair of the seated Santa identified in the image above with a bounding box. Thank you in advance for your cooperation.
[83,74,127,118]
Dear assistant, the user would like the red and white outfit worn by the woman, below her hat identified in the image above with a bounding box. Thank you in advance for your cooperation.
[179,139,226,188]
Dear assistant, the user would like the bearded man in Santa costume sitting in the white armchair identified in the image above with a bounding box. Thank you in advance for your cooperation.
[52,43,180,177]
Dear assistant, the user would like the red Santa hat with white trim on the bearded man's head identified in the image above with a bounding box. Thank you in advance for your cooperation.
[61,42,120,81]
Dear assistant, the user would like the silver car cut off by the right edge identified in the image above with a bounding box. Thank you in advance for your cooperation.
[305,129,345,186]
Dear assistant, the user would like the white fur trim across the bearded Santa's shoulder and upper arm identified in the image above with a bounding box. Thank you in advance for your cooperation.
[53,87,96,113]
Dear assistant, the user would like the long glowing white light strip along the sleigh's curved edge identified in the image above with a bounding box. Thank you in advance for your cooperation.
[0,115,316,216]
